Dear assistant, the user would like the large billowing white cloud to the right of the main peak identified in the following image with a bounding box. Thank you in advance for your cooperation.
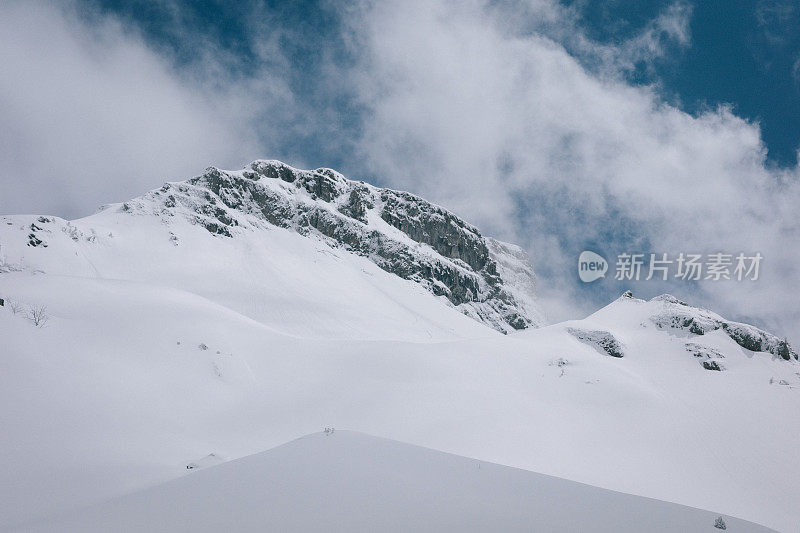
[340,1,800,338]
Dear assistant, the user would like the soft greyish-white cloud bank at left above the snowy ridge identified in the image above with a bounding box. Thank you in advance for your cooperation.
[0,1,276,216]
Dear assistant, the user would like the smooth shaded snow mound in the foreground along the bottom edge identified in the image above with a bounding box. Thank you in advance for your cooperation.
[12,431,771,533]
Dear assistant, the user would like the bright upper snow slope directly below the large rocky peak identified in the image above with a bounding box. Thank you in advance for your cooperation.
[0,209,487,340]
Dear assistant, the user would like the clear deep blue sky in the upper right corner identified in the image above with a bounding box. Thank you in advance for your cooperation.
[569,0,800,166]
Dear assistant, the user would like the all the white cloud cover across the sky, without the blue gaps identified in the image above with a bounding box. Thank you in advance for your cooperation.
[0,0,800,342]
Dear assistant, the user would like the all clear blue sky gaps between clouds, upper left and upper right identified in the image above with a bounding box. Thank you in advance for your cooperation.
[83,0,800,171]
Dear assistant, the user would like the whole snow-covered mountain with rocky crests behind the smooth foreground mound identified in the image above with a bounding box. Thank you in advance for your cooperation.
[0,161,800,531]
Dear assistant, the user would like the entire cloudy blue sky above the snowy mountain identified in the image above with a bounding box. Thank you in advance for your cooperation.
[0,0,800,336]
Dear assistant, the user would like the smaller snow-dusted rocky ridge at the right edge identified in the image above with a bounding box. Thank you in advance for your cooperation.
[631,294,798,362]
